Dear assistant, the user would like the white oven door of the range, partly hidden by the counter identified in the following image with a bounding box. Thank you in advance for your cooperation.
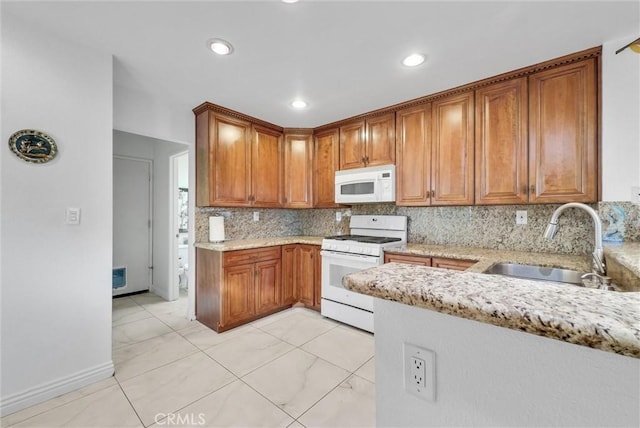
[320,250,382,312]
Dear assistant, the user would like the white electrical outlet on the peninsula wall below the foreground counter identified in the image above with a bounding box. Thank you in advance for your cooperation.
[402,343,436,401]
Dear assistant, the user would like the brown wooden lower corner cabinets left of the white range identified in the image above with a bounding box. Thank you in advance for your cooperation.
[196,244,321,332]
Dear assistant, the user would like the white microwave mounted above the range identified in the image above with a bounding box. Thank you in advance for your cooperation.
[335,165,396,204]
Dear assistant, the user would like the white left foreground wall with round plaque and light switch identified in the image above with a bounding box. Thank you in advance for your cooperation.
[0,12,113,415]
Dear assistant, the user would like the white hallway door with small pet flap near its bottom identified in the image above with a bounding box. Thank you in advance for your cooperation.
[112,156,153,296]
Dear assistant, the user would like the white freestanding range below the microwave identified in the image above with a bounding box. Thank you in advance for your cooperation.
[320,215,407,333]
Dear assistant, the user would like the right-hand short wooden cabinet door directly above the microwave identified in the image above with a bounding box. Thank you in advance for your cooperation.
[364,113,396,166]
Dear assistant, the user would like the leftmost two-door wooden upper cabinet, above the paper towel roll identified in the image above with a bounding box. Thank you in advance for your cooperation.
[196,109,282,207]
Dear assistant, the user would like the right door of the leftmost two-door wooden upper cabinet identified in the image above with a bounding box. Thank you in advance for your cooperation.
[251,126,282,208]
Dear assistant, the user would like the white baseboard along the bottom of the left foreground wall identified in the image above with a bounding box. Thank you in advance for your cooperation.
[0,361,114,416]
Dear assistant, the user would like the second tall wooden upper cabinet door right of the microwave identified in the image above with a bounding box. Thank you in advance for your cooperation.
[431,92,474,205]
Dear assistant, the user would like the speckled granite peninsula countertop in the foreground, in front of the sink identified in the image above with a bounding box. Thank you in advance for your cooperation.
[343,264,640,358]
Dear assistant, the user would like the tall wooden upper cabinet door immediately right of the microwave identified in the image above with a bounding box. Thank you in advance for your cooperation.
[396,104,431,206]
